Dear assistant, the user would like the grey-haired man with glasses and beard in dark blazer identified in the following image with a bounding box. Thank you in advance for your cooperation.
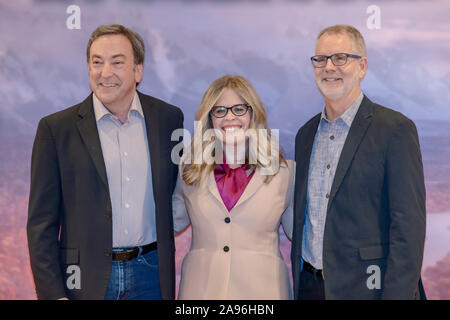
[291,25,425,299]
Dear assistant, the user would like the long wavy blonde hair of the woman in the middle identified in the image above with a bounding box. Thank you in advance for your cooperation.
[182,75,287,185]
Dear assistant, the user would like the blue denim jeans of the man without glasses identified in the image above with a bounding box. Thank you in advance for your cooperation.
[105,249,161,300]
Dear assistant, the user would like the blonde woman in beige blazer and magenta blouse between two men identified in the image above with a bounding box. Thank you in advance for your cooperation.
[173,76,295,299]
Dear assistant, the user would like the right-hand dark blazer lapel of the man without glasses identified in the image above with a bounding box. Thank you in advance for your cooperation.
[138,91,161,199]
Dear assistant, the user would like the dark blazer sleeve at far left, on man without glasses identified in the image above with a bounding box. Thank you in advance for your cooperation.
[27,118,66,299]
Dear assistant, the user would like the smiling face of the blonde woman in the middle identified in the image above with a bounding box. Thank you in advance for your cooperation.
[211,88,251,144]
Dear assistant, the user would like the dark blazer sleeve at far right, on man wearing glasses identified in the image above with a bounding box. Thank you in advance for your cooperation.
[382,119,426,299]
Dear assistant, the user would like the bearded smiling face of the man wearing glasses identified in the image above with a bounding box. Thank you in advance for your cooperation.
[314,33,367,103]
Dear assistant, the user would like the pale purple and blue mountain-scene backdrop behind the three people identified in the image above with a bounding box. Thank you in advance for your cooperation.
[0,0,450,299]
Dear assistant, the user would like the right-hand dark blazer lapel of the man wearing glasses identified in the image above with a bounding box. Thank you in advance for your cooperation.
[327,96,373,210]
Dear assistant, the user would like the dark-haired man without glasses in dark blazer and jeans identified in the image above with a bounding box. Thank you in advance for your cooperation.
[27,25,183,299]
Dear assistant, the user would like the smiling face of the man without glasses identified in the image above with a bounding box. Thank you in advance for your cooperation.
[89,34,143,111]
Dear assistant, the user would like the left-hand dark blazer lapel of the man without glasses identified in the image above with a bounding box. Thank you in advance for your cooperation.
[77,93,109,189]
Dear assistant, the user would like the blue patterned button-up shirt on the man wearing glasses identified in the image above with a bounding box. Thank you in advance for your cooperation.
[302,93,364,269]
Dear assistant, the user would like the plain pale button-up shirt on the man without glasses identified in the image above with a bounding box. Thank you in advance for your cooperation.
[93,93,156,248]
